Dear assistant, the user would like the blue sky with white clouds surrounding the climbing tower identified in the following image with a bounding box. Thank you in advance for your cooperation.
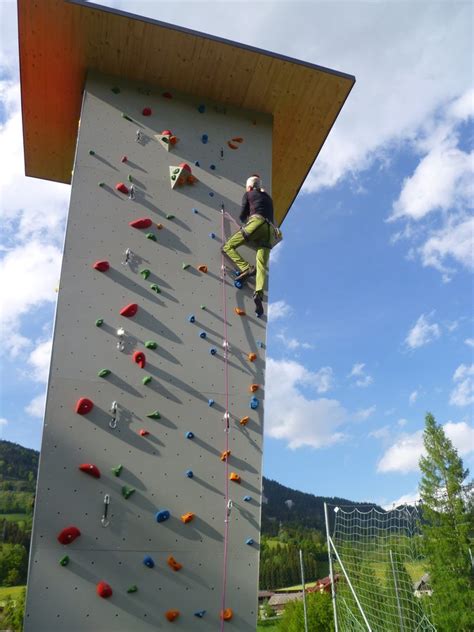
[0,0,474,506]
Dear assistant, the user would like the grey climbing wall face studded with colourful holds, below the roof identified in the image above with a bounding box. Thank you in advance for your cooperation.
[25,75,272,632]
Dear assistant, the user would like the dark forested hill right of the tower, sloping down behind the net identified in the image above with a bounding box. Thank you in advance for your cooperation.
[262,478,383,535]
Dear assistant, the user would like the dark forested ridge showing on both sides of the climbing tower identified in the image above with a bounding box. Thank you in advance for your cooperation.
[0,440,383,535]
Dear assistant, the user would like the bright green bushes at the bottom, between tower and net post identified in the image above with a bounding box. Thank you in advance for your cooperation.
[278,593,334,632]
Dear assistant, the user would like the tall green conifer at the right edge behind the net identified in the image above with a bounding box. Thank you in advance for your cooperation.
[420,413,474,632]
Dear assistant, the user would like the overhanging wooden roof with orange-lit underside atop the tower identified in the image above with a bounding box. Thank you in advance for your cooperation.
[18,0,355,223]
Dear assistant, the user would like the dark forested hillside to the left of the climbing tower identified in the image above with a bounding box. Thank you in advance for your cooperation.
[0,439,39,492]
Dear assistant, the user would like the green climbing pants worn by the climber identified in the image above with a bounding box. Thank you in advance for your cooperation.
[222,215,270,293]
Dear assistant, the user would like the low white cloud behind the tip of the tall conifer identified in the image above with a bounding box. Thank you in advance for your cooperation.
[377,421,474,474]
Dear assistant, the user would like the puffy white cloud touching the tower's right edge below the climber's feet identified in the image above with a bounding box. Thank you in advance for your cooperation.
[265,358,348,450]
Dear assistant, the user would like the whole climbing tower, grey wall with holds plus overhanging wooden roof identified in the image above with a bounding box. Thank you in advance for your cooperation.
[18,0,354,632]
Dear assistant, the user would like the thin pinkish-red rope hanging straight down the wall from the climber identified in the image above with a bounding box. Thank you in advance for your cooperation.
[221,205,235,632]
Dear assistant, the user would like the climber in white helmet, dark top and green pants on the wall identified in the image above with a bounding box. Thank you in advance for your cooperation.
[222,174,281,316]
